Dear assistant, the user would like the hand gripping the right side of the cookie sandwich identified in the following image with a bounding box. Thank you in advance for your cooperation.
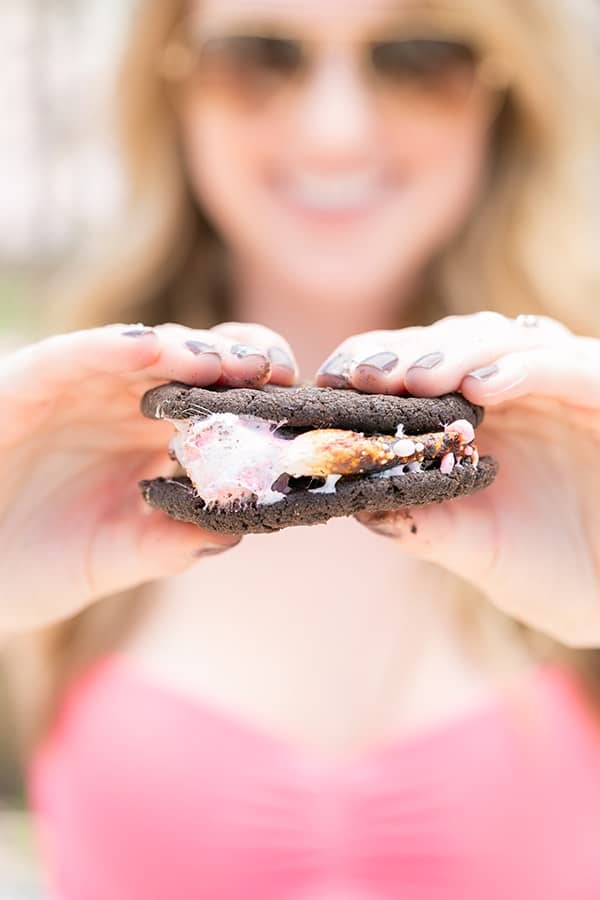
[317,312,600,646]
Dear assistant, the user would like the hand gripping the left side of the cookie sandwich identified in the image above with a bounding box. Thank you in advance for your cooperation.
[0,323,296,631]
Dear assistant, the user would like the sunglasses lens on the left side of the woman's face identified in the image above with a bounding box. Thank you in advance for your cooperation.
[200,35,304,94]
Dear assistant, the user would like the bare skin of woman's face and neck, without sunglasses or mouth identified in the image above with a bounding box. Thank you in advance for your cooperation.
[181,0,495,360]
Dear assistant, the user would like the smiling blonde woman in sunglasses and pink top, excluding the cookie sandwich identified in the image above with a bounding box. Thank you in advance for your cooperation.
[0,0,600,900]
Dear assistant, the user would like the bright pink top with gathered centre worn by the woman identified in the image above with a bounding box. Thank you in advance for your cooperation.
[30,656,600,900]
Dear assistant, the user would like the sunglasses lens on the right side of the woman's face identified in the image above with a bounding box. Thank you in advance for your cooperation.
[371,38,476,90]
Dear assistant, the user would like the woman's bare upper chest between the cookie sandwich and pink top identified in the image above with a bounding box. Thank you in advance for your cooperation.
[124,520,510,756]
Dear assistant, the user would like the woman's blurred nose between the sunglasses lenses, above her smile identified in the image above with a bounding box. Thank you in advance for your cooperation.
[298,52,375,162]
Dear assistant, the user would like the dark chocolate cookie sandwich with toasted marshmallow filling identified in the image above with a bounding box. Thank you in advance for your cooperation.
[140,384,497,534]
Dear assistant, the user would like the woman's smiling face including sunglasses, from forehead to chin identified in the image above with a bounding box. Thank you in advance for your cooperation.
[176,0,500,305]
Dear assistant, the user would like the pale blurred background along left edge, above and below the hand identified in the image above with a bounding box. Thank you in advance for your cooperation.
[0,0,133,900]
